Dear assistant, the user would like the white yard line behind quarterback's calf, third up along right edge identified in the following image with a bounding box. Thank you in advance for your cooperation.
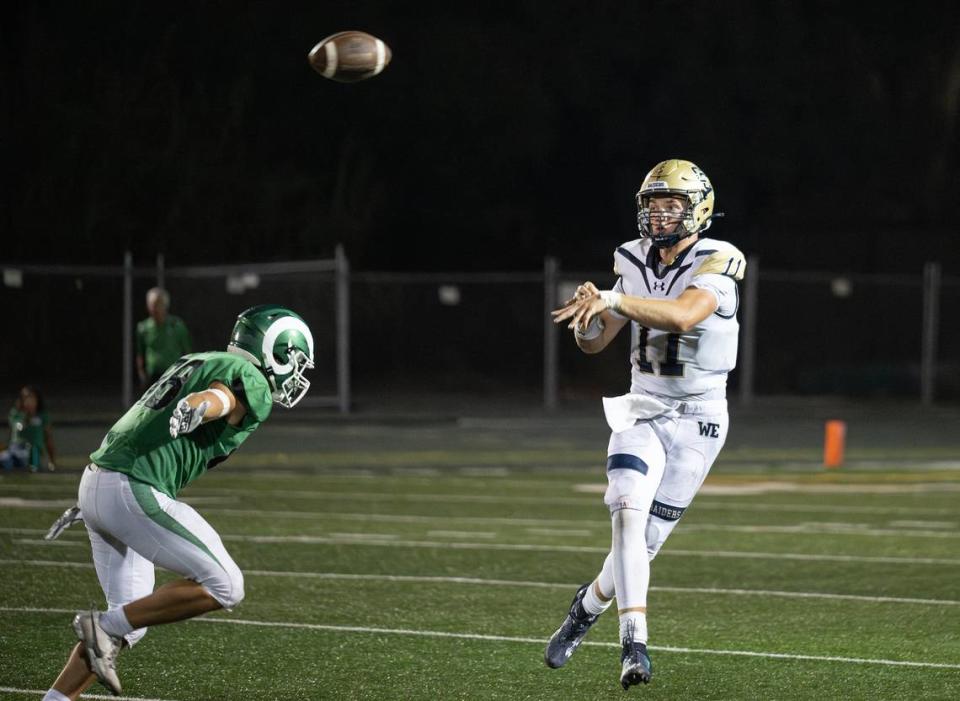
[7,528,960,565]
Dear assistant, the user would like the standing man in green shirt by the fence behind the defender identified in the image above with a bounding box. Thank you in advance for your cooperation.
[137,287,192,388]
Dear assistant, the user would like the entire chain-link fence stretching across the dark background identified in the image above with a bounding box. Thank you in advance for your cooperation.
[0,252,960,410]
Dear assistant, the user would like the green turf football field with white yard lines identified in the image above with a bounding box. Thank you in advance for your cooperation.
[0,418,960,701]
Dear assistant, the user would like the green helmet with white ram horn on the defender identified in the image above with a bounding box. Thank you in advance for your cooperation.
[227,304,313,409]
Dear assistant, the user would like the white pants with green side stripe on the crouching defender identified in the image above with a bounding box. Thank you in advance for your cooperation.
[78,465,243,645]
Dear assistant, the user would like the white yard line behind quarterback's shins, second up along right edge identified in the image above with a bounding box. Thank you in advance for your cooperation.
[0,560,960,606]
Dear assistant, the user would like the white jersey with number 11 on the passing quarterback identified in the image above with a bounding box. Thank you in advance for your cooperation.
[610,239,746,399]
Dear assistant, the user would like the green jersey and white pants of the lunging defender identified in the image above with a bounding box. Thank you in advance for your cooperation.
[79,352,272,645]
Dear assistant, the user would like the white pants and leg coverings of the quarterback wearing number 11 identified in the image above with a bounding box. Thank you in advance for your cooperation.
[597,401,729,610]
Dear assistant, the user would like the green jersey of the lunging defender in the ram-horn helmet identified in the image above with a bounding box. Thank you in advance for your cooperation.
[90,352,273,498]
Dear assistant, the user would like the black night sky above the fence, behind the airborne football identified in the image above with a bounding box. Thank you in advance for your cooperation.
[0,0,960,272]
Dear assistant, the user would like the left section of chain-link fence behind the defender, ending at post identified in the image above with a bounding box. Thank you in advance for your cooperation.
[0,254,349,410]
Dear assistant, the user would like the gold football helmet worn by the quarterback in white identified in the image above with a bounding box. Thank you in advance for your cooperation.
[637,158,713,248]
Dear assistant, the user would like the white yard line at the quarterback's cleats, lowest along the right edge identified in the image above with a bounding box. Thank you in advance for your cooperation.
[0,606,960,669]
